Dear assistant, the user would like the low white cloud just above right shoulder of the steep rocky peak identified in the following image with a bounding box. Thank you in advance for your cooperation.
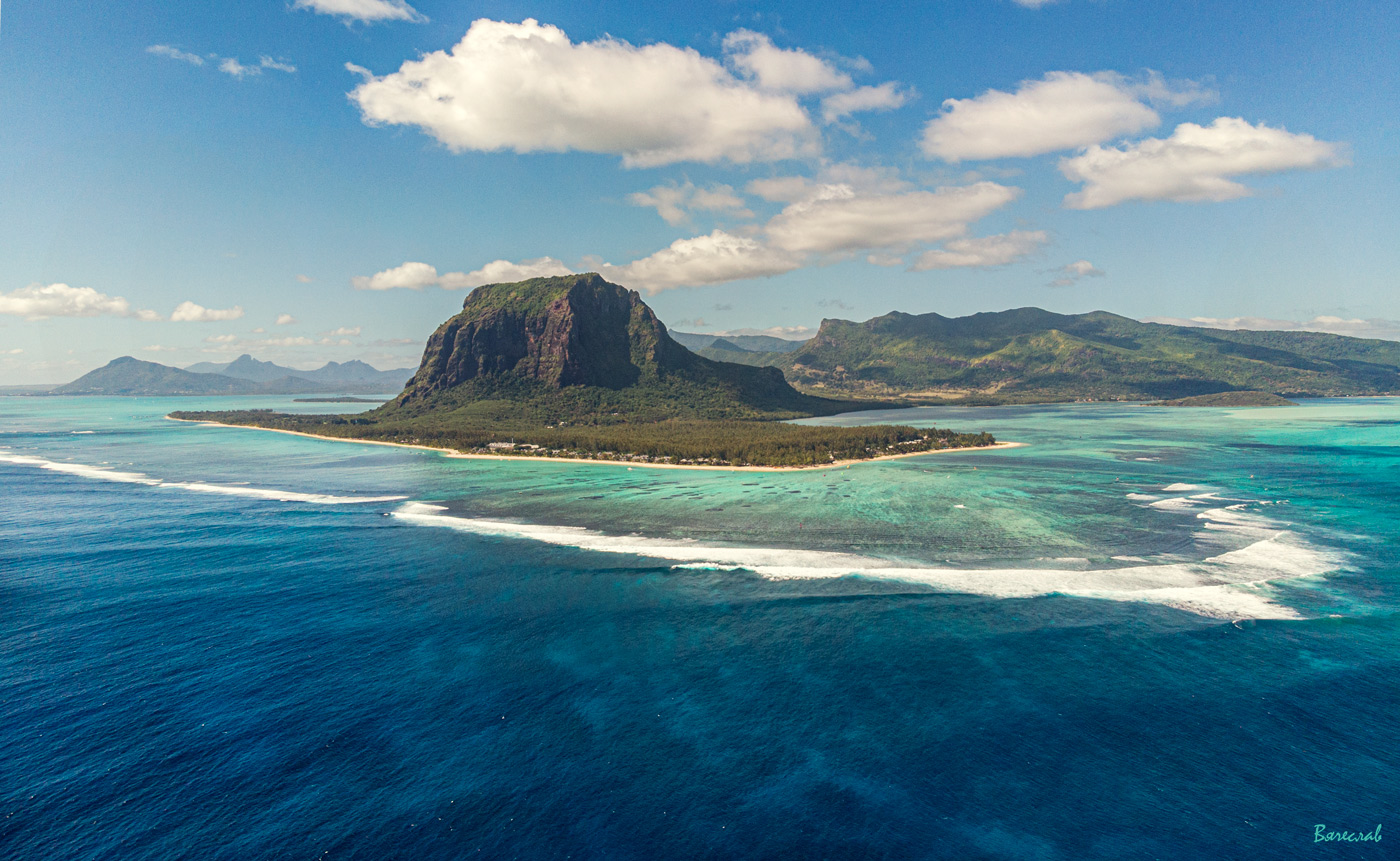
[601,230,802,293]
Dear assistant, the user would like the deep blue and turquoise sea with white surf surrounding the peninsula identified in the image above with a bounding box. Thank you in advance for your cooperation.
[0,398,1400,860]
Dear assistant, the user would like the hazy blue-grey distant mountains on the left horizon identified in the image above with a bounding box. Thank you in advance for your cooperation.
[49,354,413,395]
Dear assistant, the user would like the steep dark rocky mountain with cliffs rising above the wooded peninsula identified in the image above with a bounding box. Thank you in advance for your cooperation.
[368,273,850,424]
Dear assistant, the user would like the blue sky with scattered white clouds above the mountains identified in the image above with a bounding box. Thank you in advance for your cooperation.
[0,0,1400,385]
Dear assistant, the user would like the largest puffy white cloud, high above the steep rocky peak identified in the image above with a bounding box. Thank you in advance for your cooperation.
[347,18,815,167]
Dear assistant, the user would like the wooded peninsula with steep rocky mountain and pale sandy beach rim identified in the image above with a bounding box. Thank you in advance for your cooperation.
[171,273,997,468]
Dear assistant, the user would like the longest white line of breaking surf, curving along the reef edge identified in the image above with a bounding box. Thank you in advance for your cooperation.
[393,503,1338,619]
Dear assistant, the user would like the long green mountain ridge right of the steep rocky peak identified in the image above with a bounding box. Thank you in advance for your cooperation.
[761,308,1400,402]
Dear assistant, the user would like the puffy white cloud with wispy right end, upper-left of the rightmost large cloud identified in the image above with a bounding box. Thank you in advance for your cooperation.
[921,71,1214,162]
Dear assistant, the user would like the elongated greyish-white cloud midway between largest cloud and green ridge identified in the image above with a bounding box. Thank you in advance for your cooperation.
[766,182,1021,253]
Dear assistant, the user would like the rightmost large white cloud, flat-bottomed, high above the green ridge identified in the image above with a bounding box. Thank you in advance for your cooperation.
[1060,116,1345,209]
